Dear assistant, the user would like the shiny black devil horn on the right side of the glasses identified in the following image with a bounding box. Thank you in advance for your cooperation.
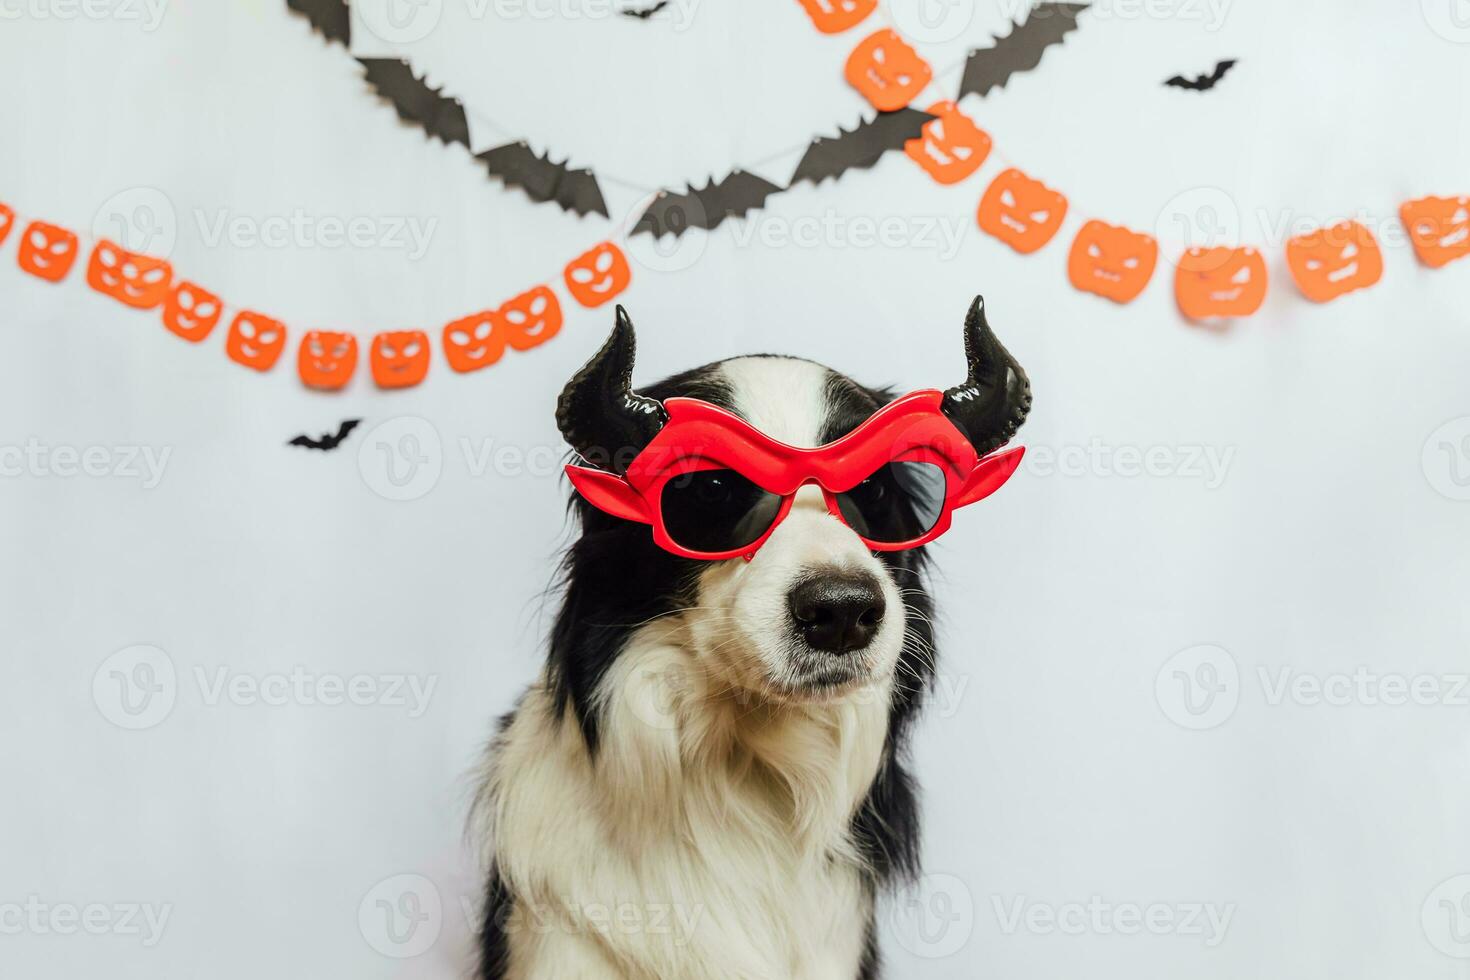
[942,297,1030,455]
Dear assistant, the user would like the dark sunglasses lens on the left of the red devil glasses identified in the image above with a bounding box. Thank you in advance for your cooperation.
[660,470,781,554]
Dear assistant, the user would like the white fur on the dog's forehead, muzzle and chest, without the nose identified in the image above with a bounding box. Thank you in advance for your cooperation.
[475,359,904,980]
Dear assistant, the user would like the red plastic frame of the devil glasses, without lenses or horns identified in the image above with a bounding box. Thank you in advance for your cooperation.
[566,389,1026,561]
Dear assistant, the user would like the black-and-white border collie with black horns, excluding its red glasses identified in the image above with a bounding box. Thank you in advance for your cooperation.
[472,298,1030,980]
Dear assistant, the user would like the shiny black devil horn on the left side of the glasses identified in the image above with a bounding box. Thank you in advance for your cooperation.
[556,306,669,473]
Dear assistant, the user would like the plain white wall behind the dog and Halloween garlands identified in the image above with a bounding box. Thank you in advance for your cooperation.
[0,0,1470,980]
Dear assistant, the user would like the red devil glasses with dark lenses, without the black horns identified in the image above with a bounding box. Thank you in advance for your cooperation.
[566,391,1025,561]
